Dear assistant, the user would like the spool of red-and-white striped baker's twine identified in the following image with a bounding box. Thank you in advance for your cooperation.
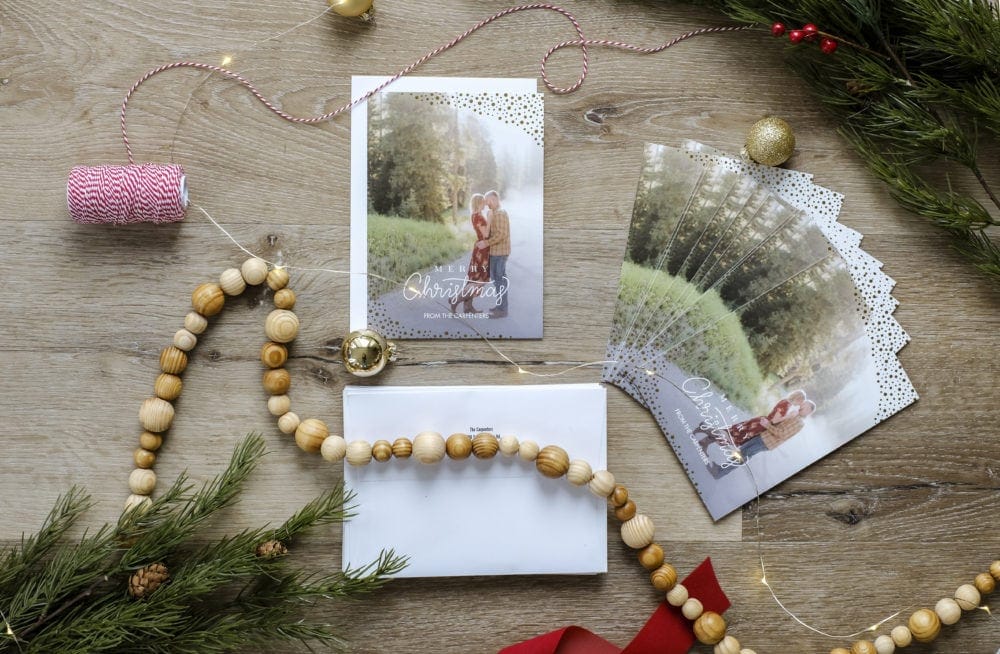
[66,163,187,225]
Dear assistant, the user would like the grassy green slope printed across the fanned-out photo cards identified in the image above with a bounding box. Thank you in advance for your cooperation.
[612,261,764,409]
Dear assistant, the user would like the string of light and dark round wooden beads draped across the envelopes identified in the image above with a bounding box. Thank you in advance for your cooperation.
[125,258,1000,654]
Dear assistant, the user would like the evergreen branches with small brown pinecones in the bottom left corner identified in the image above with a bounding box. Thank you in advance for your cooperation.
[0,435,405,654]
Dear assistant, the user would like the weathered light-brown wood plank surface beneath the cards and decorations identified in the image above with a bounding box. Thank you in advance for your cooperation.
[0,0,1000,654]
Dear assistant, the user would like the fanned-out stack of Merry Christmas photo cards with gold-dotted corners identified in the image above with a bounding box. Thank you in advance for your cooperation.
[603,143,917,519]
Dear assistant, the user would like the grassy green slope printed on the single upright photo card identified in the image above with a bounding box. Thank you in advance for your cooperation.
[368,213,473,297]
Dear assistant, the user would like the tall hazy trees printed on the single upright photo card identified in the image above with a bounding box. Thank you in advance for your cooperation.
[368,93,498,222]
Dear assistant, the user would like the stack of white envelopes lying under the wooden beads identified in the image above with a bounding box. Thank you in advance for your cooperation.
[343,384,607,577]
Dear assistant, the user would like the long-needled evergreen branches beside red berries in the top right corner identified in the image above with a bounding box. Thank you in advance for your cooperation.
[664,0,1000,279]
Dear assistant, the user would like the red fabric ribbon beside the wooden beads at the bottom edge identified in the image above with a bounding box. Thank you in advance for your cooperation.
[500,559,729,654]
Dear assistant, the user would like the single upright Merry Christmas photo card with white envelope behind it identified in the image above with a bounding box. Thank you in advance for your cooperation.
[351,77,544,338]
